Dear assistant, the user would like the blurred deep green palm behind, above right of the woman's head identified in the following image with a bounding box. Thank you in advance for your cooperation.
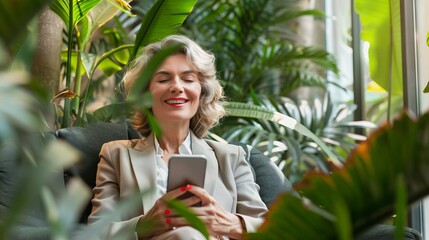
[181,0,338,102]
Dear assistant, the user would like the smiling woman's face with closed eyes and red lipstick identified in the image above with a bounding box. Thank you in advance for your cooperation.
[149,54,201,126]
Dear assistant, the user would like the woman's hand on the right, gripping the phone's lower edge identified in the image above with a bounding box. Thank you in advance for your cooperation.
[165,185,243,239]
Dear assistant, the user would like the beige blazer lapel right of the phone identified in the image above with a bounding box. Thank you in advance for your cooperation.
[191,132,218,196]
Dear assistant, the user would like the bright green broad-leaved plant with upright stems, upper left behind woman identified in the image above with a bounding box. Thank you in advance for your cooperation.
[47,0,196,127]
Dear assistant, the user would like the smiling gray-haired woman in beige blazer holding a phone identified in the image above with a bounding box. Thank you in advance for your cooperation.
[89,35,267,239]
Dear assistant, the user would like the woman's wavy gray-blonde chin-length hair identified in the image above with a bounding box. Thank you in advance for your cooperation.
[123,35,225,138]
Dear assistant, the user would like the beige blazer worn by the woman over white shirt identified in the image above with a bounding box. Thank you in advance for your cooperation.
[88,133,267,237]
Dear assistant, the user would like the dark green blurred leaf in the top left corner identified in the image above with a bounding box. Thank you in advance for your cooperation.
[0,0,50,45]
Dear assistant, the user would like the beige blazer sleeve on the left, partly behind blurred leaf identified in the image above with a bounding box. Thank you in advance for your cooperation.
[88,143,139,239]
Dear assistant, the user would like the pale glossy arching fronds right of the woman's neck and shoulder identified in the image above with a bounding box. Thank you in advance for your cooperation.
[214,95,376,183]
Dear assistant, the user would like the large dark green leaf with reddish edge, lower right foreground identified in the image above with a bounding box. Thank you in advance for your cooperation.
[248,110,429,239]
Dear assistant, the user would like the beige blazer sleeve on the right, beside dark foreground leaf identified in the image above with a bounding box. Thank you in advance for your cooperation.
[231,146,268,232]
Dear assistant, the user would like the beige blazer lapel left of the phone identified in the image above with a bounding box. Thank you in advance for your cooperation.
[128,135,156,213]
